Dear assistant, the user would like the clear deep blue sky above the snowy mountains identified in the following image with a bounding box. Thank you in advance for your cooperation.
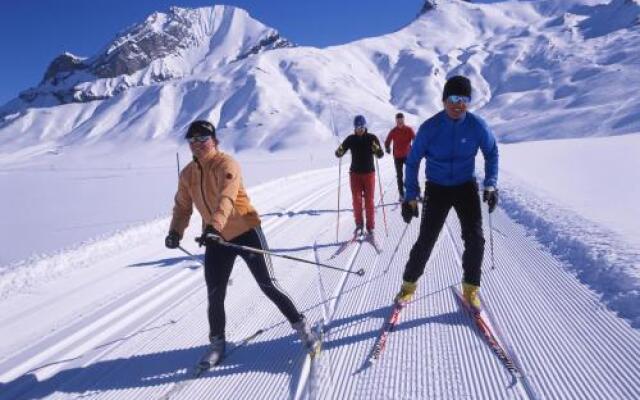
[0,0,423,104]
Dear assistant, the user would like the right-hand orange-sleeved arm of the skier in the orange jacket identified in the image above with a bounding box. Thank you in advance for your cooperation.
[213,159,242,232]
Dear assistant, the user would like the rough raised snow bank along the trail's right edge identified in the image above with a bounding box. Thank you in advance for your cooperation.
[498,178,640,328]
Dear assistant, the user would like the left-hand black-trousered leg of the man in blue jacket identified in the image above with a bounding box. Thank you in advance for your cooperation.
[402,183,451,282]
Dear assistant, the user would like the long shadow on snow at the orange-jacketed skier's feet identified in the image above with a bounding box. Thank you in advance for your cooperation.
[0,334,306,400]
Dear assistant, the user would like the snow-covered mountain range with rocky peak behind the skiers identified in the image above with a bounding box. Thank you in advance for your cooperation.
[0,0,640,154]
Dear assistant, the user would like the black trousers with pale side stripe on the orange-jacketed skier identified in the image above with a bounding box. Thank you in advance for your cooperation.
[204,227,302,338]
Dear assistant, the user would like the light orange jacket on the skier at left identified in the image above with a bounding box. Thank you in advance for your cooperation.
[170,151,260,240]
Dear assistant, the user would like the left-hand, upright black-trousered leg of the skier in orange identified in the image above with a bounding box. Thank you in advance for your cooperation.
[204,243,237,340]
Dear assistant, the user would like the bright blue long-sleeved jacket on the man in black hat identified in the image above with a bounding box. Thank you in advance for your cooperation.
[404,111,498,200]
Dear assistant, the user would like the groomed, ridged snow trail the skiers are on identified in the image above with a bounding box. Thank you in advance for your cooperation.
[0,159,640,400]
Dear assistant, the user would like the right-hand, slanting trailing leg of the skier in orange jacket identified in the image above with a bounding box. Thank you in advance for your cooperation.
[238,227,303,324]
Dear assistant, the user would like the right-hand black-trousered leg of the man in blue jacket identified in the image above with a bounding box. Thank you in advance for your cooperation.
[453,181,484,286]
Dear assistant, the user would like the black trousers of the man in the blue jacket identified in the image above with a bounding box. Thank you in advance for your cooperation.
[403,180,484,286]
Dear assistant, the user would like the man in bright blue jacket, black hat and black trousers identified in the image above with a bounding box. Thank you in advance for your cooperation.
[396,76,498,309]
